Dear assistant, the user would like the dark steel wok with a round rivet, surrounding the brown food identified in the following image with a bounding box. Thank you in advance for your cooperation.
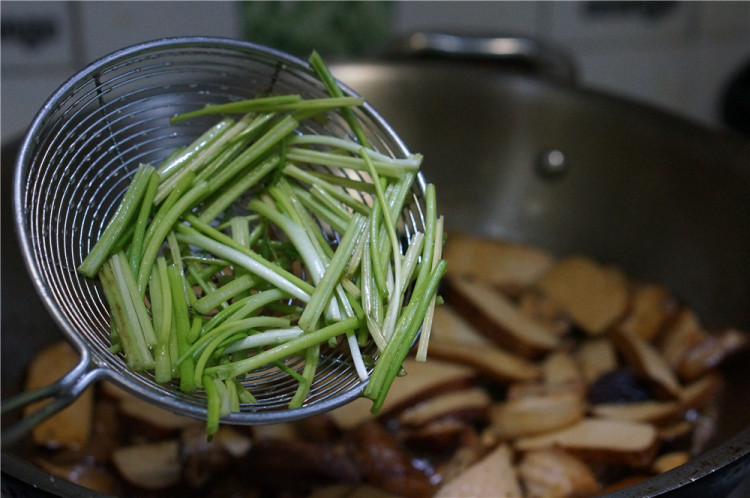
[2,33,750,497]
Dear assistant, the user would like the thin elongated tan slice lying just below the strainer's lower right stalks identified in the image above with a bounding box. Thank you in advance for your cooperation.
[398,387,492,427]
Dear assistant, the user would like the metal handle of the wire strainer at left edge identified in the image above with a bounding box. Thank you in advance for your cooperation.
[2,359,104,445]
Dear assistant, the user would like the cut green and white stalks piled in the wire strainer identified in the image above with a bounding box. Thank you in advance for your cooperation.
[78,52,446,438]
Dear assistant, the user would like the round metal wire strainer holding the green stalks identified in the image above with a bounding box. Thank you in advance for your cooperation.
[3,37,425,444]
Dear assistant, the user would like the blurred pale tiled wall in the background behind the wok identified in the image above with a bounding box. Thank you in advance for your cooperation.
[0,1,750,141]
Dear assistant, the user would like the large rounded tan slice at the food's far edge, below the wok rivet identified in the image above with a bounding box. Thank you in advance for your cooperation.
[535,256,630,335]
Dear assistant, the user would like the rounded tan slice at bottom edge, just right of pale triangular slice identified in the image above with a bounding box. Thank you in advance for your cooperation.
[518,448,599,498]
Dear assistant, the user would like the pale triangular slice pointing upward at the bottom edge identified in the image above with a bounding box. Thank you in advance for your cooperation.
[435,445,523,498]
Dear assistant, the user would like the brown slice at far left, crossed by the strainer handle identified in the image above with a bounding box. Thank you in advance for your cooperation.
[24,341,94,450]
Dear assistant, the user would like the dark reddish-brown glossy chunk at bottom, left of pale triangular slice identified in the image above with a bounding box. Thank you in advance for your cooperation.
[350,422,433,498]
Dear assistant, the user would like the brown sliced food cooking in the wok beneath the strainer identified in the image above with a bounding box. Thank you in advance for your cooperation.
[16,233,747,497]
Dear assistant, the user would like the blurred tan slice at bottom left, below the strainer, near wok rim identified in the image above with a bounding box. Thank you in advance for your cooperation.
[112,439,182,490]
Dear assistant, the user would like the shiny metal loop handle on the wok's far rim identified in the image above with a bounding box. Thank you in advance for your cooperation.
[387,31,578,84]
